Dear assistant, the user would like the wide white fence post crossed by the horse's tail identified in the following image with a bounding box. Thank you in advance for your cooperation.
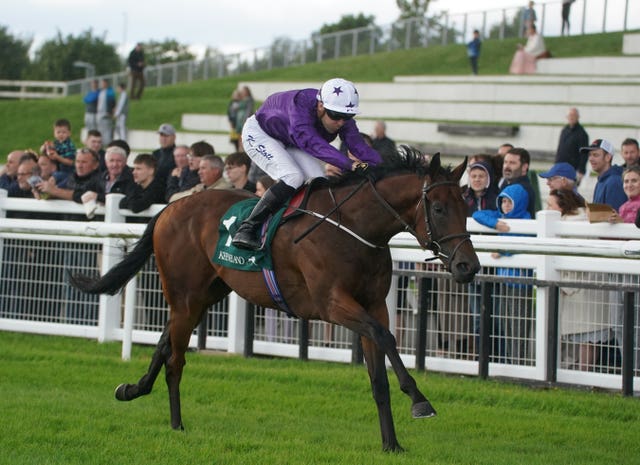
[98,194,124,342]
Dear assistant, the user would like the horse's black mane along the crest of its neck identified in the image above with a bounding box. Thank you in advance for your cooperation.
[329,145,451,186]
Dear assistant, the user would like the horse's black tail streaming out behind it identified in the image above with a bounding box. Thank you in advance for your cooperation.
[67,214,160,295]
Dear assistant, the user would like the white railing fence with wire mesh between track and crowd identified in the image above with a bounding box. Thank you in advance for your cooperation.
[0,191,640,393]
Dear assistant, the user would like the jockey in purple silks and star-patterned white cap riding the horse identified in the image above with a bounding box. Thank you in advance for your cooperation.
[232,78,382,250]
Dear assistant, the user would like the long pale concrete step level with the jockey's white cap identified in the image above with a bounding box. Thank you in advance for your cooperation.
[243,81,640,127]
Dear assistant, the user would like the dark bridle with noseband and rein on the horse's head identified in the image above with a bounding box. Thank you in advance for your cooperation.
[369,180,471,271]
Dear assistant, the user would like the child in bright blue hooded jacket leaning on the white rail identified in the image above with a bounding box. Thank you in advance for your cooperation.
[473,184,533,364]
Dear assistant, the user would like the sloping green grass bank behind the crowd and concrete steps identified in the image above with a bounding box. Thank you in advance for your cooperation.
[0,32,622,163]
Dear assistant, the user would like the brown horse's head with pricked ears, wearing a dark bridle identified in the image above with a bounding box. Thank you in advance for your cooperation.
[416,154,480,282]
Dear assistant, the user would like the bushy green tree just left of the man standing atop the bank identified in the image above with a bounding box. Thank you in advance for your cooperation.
[29,29,124,81]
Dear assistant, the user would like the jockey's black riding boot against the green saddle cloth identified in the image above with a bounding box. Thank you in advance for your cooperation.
[231,181,295,250]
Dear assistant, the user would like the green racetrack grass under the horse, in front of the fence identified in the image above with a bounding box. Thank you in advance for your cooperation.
[0,332,640,465]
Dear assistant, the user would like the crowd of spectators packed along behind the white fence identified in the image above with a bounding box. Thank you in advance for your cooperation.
[0,99,640,369]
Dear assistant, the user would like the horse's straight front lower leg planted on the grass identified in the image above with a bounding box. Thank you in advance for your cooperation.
[362,337,403,452]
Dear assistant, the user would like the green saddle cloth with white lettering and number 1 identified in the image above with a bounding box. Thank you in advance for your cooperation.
[211,199,285,271]
